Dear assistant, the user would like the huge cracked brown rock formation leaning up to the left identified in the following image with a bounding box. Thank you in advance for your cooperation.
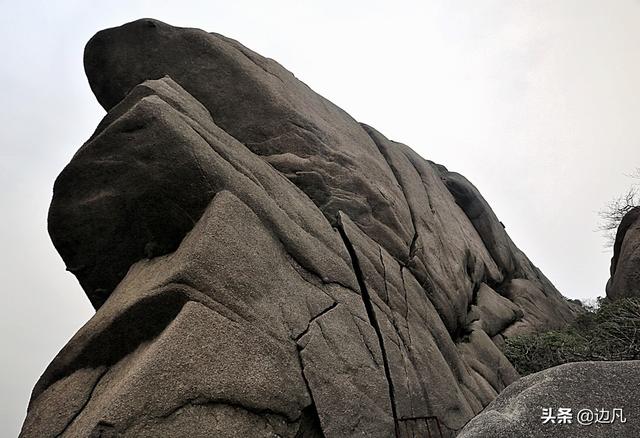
[21,19,577,437]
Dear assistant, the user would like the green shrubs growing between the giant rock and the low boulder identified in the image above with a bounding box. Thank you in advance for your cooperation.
[504,298,640,376]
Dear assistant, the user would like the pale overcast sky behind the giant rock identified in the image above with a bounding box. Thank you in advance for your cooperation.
[0,0,640,437]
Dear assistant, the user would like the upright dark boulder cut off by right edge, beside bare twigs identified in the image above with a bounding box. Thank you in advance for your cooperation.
[607,207,640,300]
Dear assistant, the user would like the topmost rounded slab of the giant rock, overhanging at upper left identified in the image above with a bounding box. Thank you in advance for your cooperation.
[84,19,413,266]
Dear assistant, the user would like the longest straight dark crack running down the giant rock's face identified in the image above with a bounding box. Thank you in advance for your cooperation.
[336,216,400,437]
